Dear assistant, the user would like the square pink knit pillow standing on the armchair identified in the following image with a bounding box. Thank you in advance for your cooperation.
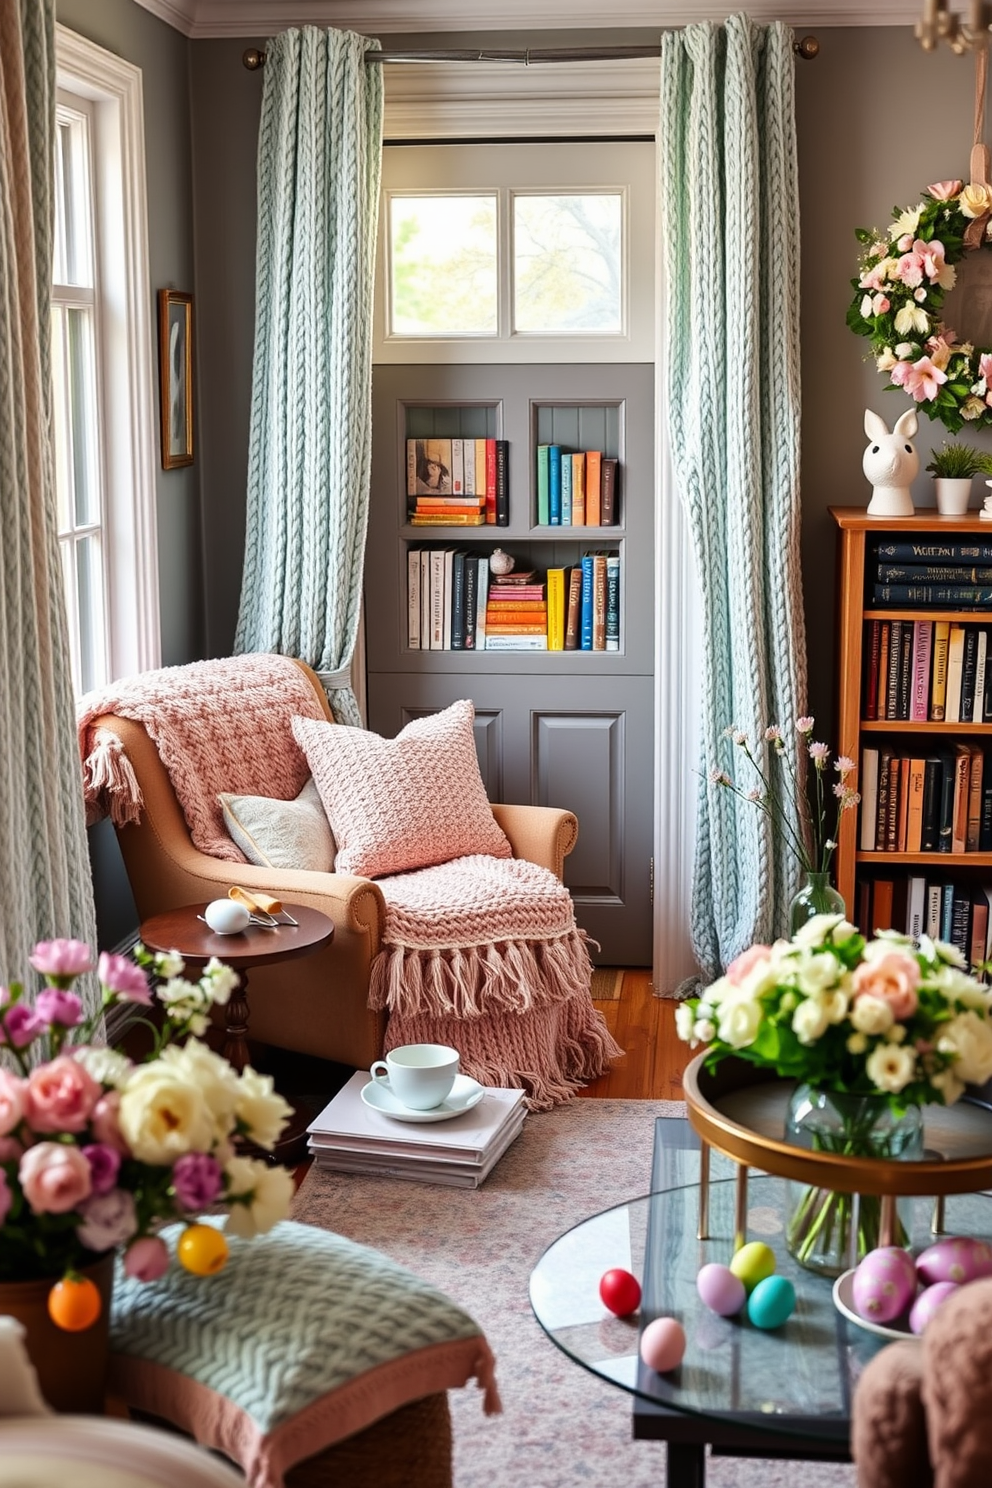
[293,699,513,878]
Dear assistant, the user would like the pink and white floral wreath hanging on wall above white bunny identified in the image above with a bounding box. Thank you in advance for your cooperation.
[848,180,992,433]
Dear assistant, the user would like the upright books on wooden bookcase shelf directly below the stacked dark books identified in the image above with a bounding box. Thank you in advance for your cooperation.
[863,620,992,723]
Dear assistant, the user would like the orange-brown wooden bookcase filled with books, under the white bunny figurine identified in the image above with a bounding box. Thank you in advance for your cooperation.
[831,507,992,964]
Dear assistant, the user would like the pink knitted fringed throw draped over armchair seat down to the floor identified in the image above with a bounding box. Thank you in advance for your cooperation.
[369,856,623,1110]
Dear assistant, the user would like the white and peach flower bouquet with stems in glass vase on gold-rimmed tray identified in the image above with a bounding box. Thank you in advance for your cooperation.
[675,915,992,1269]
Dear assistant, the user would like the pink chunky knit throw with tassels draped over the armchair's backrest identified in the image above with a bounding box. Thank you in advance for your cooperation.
[76,653,326,863]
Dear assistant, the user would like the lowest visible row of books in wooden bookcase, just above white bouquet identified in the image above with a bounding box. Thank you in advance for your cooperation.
[855,873,992,967]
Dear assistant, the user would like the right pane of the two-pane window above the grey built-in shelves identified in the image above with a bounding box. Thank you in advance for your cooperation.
[513,192,623,335]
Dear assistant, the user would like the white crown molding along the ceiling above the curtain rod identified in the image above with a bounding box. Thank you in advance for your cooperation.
[135,0,922,37]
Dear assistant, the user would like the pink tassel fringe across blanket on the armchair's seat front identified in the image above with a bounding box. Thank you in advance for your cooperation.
[369,928,592,1019]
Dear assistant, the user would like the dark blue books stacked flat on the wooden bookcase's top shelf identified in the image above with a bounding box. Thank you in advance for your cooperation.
[869,539,992,610]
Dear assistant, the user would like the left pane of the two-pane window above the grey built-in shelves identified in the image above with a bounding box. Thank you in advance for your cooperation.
[390,195,497,336]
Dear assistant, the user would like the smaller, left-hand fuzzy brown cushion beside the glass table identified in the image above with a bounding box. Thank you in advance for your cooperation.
[851,1339,934,1488]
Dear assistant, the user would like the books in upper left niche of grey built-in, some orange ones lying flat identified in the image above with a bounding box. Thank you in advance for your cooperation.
[406,439,510,527]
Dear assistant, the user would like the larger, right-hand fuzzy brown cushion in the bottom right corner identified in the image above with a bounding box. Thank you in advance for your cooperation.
[921,1278,992,1488]
